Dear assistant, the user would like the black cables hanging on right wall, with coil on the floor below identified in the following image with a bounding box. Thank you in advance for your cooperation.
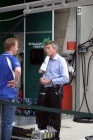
[73,28,93,123]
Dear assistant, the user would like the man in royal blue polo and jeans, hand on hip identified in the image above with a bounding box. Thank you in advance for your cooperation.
[0,38,21,140]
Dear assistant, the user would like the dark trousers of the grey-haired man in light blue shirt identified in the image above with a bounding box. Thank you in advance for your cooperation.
[36,86,62,140]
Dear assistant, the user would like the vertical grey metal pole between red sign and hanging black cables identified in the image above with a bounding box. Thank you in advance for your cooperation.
[75,7,81,111]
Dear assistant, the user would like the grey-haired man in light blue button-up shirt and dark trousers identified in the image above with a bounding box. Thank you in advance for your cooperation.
[36,41,69,140]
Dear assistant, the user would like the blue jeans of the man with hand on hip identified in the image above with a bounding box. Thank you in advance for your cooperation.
[1,99,16,140]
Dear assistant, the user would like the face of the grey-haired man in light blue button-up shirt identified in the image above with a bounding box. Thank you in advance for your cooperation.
[44,44,57,58]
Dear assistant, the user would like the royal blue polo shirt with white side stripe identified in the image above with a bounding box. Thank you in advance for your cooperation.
[0,52,20,99]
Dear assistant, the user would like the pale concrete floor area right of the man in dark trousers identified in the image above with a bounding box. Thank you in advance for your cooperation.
[60,117,93,140]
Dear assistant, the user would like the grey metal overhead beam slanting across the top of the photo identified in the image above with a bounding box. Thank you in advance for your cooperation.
[0,0,93,14]
